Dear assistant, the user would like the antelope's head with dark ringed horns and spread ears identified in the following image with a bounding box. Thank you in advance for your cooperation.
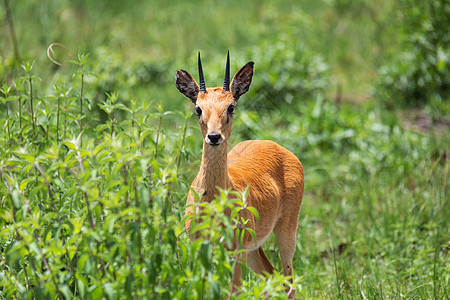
[176,52,254,147]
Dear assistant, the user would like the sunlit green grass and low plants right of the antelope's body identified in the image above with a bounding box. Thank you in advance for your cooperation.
[237,98,449,298]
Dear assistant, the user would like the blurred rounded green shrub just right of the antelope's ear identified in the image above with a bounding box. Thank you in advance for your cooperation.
[242,39,328,109]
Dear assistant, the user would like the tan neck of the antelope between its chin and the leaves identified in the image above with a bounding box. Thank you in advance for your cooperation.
[198,141,231,202]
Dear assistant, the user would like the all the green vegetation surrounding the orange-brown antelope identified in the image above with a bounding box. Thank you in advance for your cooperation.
[0,0,450,299]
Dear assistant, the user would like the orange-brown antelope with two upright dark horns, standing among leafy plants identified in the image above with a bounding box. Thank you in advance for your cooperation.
[176,52,304,298]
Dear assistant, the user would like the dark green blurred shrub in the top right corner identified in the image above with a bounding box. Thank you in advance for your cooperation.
[378,0,450,106]
